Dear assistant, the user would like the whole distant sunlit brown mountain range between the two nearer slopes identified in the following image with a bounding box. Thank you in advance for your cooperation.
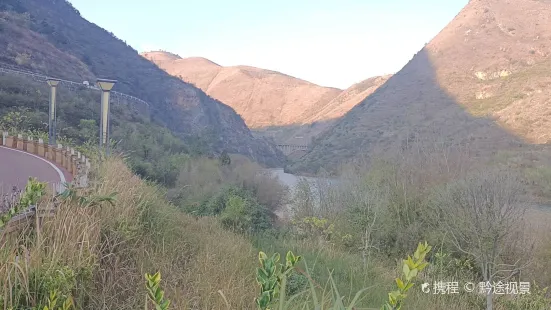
[142,51,388,145]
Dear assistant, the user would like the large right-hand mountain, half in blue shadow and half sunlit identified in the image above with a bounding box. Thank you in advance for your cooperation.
[290,0,551,172]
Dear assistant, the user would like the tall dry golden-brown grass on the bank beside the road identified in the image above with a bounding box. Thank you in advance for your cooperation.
[0,159,256,309]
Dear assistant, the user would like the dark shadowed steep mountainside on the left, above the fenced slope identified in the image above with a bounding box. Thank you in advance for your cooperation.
[0,0,283,166]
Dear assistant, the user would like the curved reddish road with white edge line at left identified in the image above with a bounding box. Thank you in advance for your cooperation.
[0,146,71,195]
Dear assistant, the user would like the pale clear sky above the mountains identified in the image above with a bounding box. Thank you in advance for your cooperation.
[70,0,468,89]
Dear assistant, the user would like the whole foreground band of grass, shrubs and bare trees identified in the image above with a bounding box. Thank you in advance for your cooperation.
[4,139,551,310]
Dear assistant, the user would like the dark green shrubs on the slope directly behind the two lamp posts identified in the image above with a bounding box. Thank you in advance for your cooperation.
[0,75,196,186]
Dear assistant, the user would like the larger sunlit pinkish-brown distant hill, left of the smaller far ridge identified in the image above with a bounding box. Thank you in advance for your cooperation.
[142,52,341,129]
